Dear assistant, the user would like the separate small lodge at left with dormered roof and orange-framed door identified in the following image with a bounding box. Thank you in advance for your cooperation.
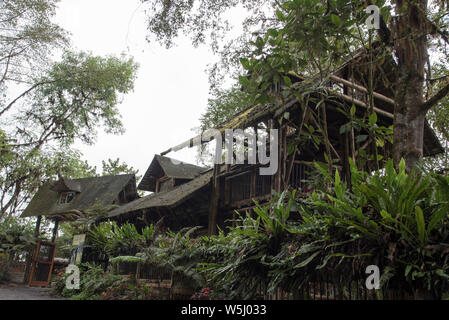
[21,174,138,286]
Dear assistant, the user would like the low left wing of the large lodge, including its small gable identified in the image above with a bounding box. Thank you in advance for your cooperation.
[104,155,212,230]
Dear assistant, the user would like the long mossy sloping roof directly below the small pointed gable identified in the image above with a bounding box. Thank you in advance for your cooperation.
[108,171,212,217]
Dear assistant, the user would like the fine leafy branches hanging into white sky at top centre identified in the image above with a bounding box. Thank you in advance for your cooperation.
[141,0,279,89]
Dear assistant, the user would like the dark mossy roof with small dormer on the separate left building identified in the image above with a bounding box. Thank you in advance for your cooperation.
[21,174,135,218]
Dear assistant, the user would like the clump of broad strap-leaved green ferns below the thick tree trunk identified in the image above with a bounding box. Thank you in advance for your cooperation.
[300,161,449,295]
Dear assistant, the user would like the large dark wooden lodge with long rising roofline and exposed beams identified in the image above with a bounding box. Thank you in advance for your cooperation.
[100,50,444,234]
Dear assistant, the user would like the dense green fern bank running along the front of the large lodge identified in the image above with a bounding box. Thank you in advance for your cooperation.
[54,161,449,299]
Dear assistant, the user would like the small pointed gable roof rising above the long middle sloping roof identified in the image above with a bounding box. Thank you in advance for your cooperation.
[138,155,207,191]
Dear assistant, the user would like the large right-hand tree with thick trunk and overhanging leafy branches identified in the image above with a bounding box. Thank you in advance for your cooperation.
[142,0,449,171]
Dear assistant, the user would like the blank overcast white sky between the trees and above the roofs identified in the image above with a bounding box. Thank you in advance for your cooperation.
[56,0,216,179]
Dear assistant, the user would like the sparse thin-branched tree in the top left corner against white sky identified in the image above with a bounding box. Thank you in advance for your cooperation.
[0,0,69,96]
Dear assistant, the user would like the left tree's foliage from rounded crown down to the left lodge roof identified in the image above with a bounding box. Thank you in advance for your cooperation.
[0,52,137,217]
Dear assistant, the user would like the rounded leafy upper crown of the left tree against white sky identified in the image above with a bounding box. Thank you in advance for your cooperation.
[19,51,137,144]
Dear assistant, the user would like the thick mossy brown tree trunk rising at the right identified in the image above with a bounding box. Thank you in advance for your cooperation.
[393,0,428,171]
